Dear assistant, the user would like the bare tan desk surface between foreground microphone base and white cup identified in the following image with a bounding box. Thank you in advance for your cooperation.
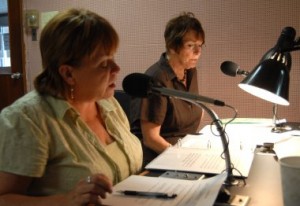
[229,154,283,206]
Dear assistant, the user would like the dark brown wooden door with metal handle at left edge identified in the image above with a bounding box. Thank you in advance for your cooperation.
[0,0,26,110]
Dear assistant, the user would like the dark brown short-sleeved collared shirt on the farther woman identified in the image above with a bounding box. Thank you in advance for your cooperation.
[131,53,202,140]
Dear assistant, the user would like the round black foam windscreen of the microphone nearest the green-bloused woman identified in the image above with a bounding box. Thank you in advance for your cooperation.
[122,73,151,98]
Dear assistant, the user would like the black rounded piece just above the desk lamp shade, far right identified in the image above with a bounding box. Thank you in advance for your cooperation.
[274,27,296,52]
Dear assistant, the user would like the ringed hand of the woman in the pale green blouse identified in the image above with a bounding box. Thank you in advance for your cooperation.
[66,174,112,206]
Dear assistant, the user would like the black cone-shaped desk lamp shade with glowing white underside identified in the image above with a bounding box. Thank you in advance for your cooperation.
[239,59,290,106]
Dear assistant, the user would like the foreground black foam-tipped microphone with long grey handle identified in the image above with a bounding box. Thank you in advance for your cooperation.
[122,73,225,106]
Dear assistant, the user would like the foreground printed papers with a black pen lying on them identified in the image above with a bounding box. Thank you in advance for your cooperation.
[103,173,227,206]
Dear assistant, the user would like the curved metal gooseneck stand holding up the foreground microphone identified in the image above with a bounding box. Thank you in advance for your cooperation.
[175,97,238,186]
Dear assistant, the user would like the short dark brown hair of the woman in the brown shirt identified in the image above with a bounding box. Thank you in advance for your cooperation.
[164,12,205,52]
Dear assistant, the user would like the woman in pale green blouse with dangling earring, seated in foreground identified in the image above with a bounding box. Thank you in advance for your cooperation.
[0,9,142,206]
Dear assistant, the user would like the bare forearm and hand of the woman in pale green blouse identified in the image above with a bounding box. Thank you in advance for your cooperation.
[0,172,112,206]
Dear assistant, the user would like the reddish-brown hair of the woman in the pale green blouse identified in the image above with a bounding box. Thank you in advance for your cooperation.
[34,9,119,98]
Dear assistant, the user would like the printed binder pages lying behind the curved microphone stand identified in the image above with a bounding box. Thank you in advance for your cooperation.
[145,146,254,177]
